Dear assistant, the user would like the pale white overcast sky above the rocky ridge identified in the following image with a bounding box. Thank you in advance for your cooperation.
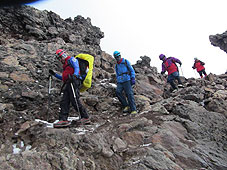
[28,0,227,78]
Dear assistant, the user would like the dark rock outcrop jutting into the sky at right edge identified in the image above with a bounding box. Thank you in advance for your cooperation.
[209,31,227,53]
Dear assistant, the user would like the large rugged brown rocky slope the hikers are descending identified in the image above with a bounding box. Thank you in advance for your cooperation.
[0,6,227,170]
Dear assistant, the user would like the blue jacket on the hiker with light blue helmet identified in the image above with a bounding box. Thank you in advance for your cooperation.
[115,58,135,83]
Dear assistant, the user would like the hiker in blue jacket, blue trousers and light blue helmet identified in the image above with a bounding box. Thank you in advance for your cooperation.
[113,51,137,114]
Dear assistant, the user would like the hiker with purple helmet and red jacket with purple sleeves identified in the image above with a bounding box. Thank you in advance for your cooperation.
[159,54,183,91]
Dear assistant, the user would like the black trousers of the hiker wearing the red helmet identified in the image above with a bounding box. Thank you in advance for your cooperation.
[59,80,89,120]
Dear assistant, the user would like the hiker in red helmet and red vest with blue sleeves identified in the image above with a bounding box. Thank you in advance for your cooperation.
[49,49,89,127]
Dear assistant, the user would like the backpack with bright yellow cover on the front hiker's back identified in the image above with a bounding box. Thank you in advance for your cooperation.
[75,54,94,93]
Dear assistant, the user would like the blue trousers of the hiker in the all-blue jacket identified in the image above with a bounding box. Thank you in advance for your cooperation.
[116,81,136,111]
